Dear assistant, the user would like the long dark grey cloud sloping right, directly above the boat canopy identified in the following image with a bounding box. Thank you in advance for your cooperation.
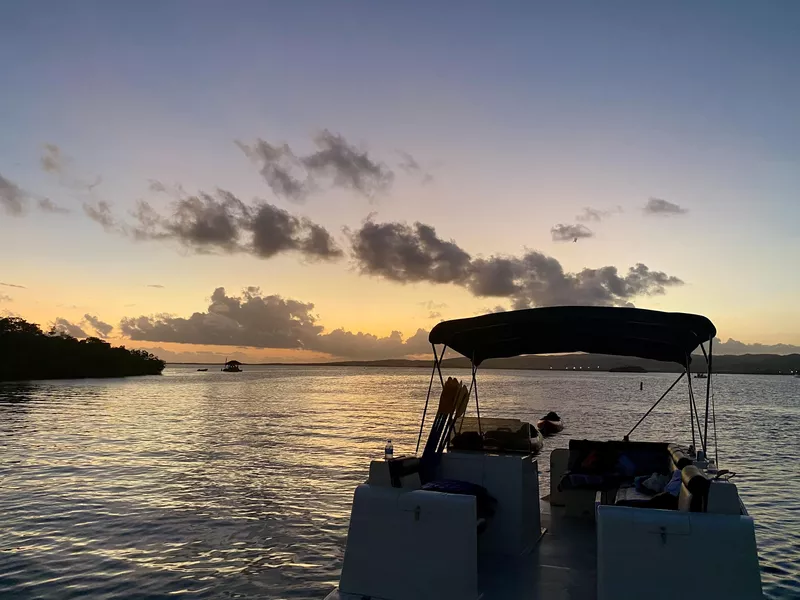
[350,221,683,308]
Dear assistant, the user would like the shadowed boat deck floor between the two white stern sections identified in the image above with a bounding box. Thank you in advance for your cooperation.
[478,499,597,600]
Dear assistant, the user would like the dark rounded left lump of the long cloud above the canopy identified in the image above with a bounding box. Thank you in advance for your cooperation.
[351,221,471,283]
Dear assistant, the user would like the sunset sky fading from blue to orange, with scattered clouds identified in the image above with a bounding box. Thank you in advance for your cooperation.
[0,0,800,361]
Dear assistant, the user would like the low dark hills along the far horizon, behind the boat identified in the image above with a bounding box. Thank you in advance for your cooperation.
[258,354,800,375]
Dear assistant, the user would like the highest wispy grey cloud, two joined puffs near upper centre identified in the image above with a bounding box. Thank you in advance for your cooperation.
[236,129,394,202]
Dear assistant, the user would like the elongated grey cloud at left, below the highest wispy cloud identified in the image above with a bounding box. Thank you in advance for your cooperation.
[92,189,344,260]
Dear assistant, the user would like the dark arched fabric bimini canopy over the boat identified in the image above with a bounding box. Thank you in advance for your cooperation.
[428,306,717,367]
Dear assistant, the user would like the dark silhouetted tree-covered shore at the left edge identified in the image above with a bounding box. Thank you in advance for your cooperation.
[0,317,166,381]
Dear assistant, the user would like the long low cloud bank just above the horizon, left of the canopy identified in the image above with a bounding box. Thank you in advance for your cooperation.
[119,287,429,358]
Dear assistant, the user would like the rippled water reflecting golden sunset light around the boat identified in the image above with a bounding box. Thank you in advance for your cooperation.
[0,367,800,600]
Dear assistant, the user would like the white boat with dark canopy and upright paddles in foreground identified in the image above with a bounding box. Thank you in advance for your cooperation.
[328,307,762,600]
